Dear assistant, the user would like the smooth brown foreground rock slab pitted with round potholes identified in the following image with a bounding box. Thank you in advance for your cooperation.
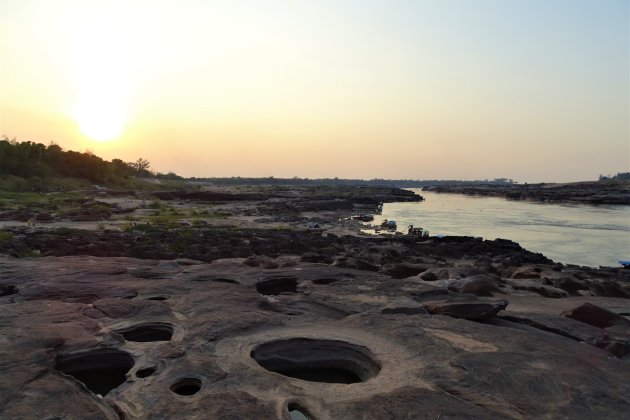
[0,254,630,419]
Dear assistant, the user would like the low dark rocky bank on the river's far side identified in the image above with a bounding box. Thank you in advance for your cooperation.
[423,181,630,205]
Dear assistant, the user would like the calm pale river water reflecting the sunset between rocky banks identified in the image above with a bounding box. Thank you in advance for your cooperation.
[373,189,630,267]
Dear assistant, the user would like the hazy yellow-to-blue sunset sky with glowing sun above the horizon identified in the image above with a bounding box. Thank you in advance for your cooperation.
[0,0,630,182]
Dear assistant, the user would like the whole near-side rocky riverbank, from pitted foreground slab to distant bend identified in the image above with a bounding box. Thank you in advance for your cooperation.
[0,188,630,419]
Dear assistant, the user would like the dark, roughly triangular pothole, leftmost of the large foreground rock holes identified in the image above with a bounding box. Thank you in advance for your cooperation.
[55,349,134,395]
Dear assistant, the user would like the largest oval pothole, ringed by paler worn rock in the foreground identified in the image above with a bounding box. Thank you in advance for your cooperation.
[251,338,381,384]
